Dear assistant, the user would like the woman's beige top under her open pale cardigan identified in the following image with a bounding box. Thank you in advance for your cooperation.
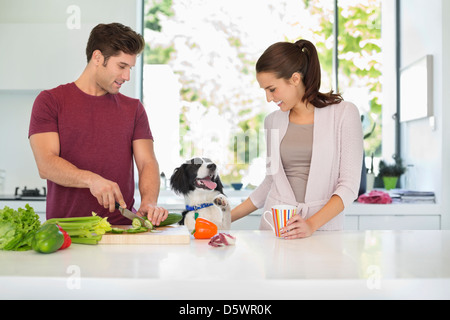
[280,122,314,203]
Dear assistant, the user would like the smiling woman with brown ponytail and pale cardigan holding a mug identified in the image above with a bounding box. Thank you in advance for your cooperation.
[231,40,363,239]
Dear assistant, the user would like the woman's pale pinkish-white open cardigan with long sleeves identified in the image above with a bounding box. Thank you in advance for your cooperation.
[250,101,363,230]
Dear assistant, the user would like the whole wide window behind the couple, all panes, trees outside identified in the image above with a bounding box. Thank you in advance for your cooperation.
[143,0,382,186]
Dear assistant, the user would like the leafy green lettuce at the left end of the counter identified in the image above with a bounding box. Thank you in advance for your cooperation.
[0,204,41,251]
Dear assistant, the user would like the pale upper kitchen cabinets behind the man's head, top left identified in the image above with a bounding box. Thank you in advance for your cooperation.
[0,0,142,97]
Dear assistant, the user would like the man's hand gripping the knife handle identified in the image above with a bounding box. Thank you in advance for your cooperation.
[89,175,127,212]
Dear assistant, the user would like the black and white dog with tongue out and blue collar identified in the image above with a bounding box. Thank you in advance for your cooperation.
[170,157,231,231]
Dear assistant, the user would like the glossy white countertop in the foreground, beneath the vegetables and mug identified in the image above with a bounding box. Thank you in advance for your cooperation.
[0,230,450,300]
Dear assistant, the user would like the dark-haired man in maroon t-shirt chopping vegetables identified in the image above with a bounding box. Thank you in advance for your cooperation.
[29,23,168,225]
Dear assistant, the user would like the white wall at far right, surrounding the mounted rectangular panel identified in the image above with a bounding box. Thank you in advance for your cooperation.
[400,0,450,228]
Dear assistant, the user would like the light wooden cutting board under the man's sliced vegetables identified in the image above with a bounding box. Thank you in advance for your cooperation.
[99,225,191,244]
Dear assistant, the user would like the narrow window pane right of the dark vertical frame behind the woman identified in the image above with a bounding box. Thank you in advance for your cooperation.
[337,0,382,162]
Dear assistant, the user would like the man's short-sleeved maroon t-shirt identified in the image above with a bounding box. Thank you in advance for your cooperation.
[28,83,153,224]
